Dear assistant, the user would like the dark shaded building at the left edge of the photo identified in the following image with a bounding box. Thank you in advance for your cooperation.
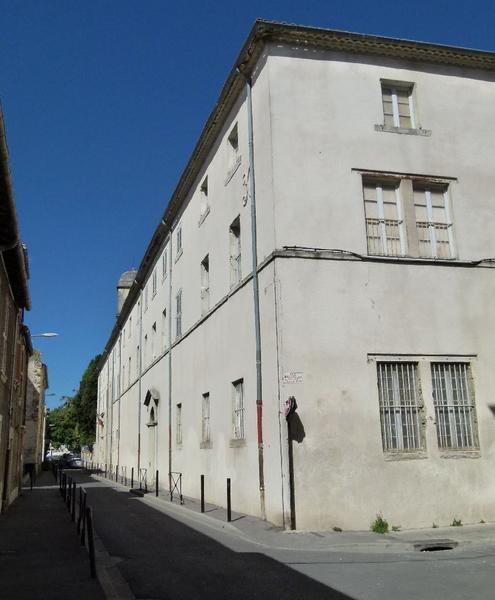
[0,106,32,511]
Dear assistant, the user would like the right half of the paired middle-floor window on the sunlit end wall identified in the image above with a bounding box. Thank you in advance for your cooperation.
[413,184,454,258]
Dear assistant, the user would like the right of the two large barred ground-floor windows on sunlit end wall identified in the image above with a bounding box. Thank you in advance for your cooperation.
[431,363,479,450]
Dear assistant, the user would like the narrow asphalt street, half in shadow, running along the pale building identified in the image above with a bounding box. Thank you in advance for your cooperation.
[72,472,495,600]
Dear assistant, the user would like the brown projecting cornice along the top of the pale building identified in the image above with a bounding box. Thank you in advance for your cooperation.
[100,20,495,368]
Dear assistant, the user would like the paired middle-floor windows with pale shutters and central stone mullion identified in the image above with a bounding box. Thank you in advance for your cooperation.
[363,173,455,260]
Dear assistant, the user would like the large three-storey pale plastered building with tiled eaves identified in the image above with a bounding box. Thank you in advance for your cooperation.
[96,21,495,529]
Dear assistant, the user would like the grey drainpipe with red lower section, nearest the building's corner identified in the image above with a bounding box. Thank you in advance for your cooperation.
[237,68,266,519]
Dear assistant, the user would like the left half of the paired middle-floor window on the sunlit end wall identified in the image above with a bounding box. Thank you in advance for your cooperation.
[363,181,407,256]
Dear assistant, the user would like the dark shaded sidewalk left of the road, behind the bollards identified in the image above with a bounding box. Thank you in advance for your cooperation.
[0,471,105,600]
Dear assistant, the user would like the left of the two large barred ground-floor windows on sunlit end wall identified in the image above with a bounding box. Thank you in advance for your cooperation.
[377,362,424,452]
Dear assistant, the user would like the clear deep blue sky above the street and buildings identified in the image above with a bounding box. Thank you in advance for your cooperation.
[0,0,495,406]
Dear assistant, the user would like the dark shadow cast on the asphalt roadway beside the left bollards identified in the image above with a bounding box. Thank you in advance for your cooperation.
[70,473,352,600]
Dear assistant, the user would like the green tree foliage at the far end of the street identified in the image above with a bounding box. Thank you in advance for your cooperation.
[48,355,100,451]
